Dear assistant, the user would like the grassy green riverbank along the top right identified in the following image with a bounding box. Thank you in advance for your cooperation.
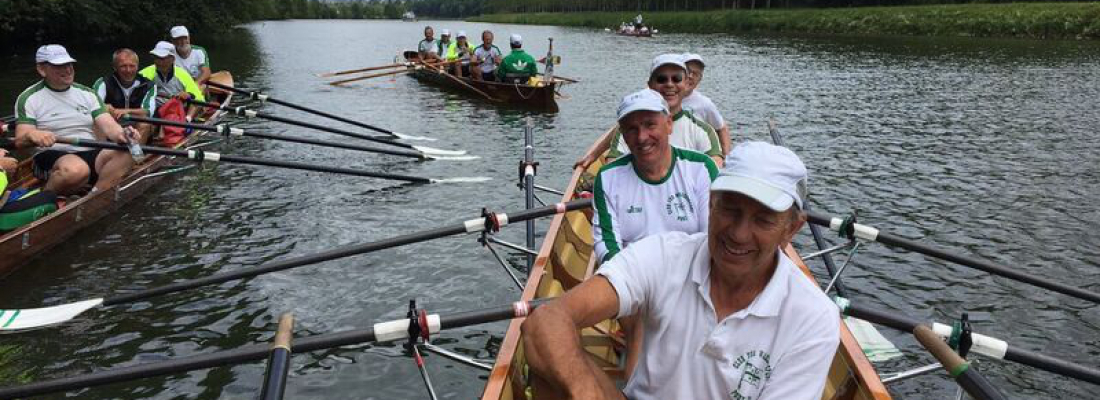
[470,2,1100,40]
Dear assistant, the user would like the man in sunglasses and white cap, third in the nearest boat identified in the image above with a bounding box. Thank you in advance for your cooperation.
[576,54,725,168]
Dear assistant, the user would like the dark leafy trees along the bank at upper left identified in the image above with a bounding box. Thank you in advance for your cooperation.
[0,0,406,49]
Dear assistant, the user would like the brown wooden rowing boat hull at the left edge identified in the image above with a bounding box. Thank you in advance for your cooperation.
[0,71,233,278]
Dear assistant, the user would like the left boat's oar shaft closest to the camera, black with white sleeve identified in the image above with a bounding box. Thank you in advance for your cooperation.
[57,138,431,184]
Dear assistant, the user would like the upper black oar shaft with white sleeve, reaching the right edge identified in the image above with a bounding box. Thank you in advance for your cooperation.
[806,210,1100,303]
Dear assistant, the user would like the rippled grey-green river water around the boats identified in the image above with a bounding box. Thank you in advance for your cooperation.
[0,21,1100,399]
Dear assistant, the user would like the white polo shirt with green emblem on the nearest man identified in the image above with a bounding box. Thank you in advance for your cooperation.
[598,232,840,400]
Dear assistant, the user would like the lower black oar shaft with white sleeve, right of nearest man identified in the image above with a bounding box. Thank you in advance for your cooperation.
[842,298,1100,385]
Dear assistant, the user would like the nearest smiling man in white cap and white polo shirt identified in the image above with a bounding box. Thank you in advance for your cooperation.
[523,142,840,400]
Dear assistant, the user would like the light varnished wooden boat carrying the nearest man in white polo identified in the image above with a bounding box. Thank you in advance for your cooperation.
[482,131,890,400]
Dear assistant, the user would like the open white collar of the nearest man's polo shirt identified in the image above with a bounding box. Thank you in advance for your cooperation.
[691,241,794,318]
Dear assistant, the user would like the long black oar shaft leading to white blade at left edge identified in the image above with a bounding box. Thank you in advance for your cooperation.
[103,199,592,305]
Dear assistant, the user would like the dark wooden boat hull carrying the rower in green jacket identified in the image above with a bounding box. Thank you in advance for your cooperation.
[404,51,564,111]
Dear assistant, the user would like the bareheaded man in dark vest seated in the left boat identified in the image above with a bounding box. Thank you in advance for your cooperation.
[91,48,156,144]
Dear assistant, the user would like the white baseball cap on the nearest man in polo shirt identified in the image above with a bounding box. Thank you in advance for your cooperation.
[711,142,807,212]
